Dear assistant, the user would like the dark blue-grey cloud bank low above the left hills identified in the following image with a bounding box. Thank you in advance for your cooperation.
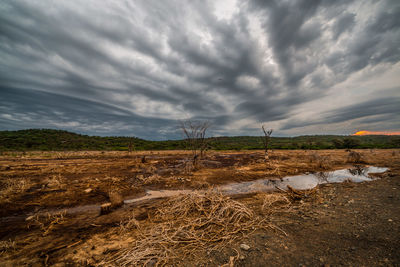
[0,87,177,139]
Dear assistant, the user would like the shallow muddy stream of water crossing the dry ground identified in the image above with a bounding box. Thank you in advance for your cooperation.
[0,169,388,222]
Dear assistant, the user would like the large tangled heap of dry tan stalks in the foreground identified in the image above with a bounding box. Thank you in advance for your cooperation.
[104,191,264,266]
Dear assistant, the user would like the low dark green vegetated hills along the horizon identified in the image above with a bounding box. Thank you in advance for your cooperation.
[0,129,400,151]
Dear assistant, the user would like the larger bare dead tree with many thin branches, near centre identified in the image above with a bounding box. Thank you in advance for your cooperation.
[180,120,211,165]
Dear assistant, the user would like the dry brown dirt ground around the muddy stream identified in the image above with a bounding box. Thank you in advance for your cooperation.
[0,150,400,266]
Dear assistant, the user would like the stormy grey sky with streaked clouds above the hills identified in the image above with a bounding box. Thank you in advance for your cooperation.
[0,0,400,140]
